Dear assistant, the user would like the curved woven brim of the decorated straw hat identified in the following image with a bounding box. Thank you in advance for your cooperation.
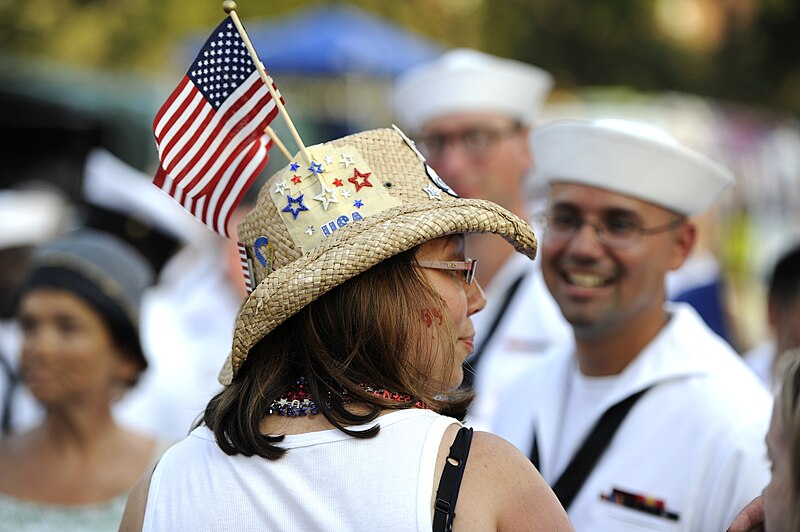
[219,199,537,384]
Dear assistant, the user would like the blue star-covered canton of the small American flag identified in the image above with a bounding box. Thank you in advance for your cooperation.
[188,17,256,109]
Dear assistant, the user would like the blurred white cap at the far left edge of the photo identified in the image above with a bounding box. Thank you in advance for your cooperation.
[0,189,67,249]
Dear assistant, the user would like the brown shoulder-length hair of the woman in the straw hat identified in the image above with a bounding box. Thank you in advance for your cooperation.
[203,244,473,459]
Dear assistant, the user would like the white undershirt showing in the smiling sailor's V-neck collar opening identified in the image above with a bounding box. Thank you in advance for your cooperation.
[550,364,619,481]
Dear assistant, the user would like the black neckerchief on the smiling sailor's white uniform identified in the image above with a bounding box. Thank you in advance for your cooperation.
[530,388,650,510]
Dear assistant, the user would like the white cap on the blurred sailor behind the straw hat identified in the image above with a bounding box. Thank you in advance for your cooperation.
[392,48,553,132]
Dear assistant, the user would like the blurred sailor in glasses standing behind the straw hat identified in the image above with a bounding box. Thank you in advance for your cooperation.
[392,49,571,428]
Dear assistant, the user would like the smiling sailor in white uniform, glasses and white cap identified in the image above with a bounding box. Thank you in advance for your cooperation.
[493,120,770,532]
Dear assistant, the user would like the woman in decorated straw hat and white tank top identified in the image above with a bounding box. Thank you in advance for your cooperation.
[122,129,572,530]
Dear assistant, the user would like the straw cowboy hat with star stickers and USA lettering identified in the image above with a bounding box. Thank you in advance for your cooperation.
[220,128,537,385]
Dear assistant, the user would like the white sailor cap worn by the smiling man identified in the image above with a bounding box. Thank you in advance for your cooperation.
[533,119,734,216]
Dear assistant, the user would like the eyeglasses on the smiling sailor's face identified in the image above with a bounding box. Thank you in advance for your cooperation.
[539,213,686,248]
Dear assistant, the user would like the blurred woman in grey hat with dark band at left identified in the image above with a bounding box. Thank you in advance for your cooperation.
[0,230,165,531]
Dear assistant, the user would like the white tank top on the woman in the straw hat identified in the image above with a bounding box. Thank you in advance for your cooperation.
[143,409,458,532]
